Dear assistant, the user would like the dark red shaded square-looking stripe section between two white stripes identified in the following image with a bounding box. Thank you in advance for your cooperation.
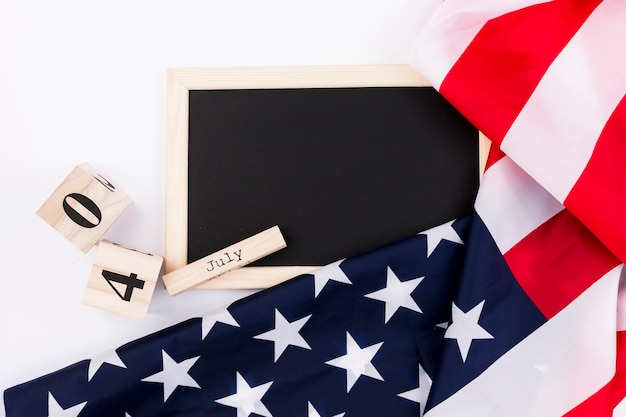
[504,210,620,319]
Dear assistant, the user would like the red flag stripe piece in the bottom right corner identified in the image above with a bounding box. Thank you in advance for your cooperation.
[565,332,626,417]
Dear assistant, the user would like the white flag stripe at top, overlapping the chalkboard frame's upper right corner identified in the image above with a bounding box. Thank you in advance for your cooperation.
[409,0,549,89]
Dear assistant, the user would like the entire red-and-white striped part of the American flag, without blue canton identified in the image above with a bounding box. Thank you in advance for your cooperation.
[410,0,626,417]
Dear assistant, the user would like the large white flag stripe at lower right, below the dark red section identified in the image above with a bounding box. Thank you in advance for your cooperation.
[425,265,622,417]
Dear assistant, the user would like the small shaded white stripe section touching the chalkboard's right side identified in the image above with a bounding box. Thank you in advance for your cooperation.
[474,157,563,253]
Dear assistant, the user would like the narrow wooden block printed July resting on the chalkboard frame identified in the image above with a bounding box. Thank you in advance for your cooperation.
[163,226,287,295]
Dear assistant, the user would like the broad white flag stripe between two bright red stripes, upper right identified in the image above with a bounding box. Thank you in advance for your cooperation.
[501,0,626,202]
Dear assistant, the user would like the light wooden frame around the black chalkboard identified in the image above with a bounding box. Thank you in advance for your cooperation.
[165,65,485,289]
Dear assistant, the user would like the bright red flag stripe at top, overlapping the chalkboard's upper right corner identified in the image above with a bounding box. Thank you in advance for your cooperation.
[440,0,601,145]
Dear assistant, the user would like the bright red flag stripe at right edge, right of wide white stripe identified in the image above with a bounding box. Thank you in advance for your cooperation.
[564,96,626,262]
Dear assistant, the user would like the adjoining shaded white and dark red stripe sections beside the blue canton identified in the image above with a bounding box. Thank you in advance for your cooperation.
[475,156,621,316]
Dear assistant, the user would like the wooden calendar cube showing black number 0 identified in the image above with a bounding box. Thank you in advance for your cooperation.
[37,163,131,252]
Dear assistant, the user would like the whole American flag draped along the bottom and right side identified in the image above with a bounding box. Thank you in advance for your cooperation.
[4,0,626,417]
